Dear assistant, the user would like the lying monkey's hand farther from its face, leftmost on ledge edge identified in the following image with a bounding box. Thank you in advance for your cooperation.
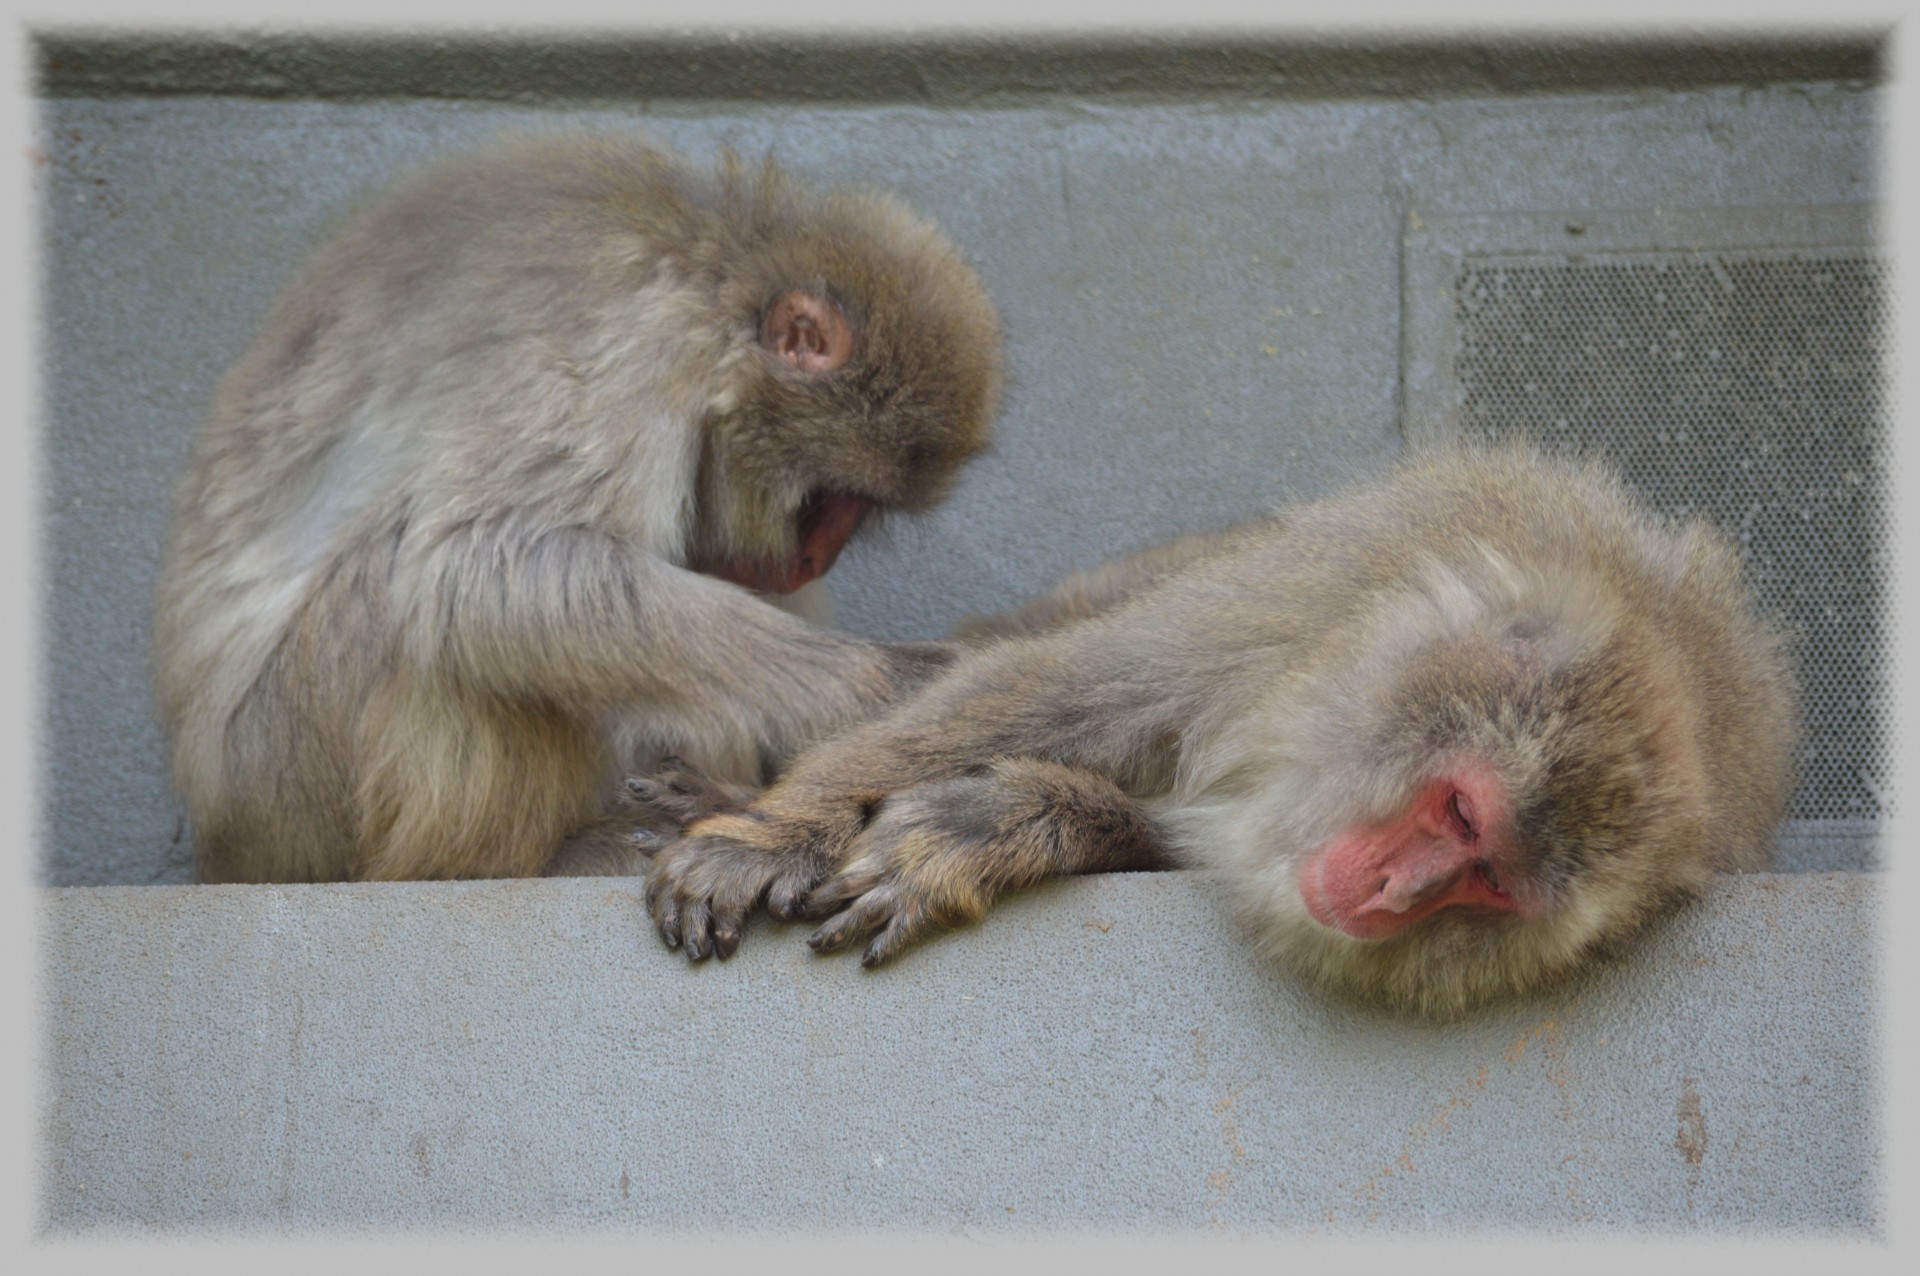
[647,810,833,961]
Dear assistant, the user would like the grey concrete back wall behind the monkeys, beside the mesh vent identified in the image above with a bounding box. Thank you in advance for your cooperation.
[36,77,1878,885]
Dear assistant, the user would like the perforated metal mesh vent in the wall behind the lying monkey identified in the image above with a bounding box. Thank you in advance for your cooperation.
[1453,249,1893,821]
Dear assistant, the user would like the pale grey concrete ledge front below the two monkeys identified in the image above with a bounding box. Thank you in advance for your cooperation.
[40,873,1885,1238]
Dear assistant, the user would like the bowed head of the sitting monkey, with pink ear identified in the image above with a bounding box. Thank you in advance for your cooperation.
[695,171,1000,593]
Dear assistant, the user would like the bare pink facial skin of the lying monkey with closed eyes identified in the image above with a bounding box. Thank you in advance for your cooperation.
[1300,764,1532,940]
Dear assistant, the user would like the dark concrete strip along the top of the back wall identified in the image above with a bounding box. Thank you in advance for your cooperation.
[33,27,1887,106]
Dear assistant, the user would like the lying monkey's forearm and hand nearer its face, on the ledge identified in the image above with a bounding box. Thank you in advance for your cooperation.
[799,758,1167,967]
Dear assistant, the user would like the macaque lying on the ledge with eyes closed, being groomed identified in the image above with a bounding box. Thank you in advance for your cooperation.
[639,449,1797,1017]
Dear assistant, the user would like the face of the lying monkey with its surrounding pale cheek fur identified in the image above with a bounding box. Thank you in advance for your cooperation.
[1210,606,1707,1017]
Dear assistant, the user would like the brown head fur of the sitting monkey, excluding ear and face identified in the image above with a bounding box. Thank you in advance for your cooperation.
[697,154,1000,556]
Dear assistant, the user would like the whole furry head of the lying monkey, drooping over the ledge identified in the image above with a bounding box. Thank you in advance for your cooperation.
[1210,518,1793,1017]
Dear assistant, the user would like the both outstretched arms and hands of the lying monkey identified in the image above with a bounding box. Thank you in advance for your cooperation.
[647,626,1181,965]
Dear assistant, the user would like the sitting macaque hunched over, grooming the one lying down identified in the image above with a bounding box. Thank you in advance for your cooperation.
[154,138,1000,881]
